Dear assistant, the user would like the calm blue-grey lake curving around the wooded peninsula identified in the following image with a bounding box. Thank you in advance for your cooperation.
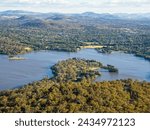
[0,49,150,90]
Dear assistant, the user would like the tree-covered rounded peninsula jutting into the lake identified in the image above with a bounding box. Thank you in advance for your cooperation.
[51,58,102,82]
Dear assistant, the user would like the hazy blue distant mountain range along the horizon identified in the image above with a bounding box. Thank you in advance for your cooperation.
[0,10,150,20]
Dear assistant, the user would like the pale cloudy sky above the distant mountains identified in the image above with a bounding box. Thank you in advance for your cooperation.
[0,0,150,13]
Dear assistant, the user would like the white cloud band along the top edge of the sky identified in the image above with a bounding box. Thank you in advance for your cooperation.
[0,0,150,6]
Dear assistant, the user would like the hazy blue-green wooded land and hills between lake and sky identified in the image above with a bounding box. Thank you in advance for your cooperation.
[0,11,150,59]
